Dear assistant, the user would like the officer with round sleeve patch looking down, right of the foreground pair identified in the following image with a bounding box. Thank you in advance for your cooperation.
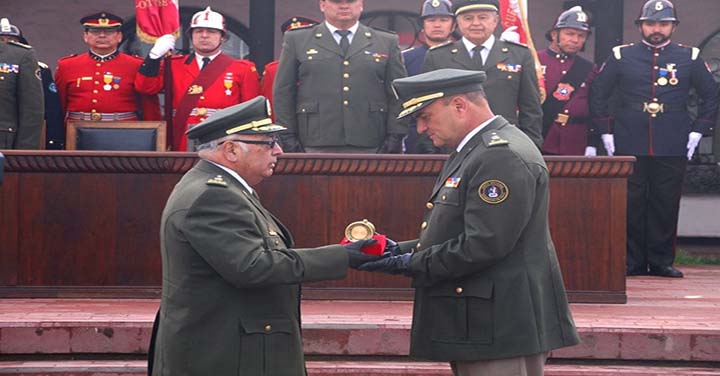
[360,69,579,376]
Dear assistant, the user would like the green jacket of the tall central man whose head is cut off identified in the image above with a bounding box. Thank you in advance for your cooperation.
[273,22,407,147]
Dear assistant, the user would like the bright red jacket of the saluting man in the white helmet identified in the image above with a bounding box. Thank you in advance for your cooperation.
[137,54,260,151]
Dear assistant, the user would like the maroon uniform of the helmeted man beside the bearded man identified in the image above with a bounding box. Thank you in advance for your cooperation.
[538,49,597,155]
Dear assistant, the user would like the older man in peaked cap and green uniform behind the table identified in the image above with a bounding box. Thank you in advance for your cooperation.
[423,0,543,147]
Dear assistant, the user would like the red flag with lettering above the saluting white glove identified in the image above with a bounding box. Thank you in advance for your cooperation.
[135,0,180,43]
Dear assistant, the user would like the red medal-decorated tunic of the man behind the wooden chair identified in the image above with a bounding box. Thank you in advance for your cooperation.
[55,52,160,121]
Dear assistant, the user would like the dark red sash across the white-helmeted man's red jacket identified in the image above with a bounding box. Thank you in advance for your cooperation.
[173,54,234,151]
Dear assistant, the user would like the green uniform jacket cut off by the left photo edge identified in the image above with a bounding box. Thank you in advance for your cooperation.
[0,42,45,149]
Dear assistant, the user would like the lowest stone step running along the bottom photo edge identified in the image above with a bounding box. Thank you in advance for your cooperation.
[0,360,720,376]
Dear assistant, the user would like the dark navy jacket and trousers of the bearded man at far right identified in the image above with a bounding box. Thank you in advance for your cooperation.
[590,43,718,274]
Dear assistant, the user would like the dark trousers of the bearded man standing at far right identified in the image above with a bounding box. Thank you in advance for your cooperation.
[627,156,687,271]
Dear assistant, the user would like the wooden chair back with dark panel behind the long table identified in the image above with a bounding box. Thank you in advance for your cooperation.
[65,120,167,151]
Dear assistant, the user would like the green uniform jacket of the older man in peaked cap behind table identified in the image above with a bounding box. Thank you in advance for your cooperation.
[423,39,543,148]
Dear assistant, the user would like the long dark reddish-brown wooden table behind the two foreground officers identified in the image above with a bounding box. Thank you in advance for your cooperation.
[0,151,634,303]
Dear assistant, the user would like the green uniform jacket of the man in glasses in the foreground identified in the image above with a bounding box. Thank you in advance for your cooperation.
[153,161,348,376]
